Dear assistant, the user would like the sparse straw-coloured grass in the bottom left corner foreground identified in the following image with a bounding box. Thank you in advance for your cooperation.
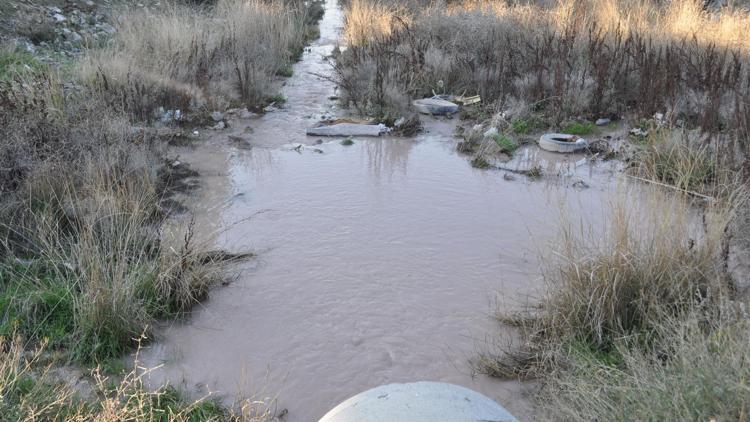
[0,337,274,422]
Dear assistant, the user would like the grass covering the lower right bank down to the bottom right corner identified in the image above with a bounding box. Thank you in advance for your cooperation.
[474,184,750,420]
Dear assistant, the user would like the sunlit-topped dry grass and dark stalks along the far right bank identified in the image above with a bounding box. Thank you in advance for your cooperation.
[337,0,750,144]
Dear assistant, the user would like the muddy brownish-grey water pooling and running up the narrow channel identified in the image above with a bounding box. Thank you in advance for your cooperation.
[141,0,617,421]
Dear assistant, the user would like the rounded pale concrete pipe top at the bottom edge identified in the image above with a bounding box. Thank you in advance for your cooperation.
[319,381,516,422]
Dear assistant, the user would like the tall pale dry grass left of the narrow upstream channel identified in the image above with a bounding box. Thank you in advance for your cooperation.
[81,0,312,120]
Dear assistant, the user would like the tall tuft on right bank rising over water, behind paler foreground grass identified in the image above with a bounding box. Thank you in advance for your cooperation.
[476,186,744,382]
